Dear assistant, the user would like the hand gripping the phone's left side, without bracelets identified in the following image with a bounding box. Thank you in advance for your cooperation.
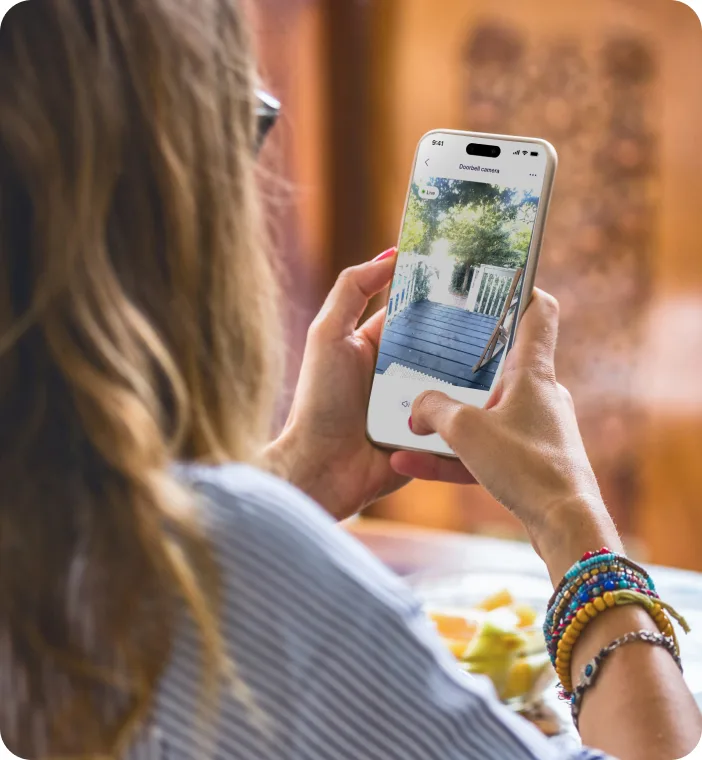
[266,249,408,520]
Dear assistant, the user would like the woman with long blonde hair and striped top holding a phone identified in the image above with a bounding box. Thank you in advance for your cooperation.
[0,0,701,760]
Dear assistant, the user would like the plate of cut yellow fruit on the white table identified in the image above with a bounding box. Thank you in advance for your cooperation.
[410,573,555,711]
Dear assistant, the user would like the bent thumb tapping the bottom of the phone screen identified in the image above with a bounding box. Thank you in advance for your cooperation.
[410,391,486,456]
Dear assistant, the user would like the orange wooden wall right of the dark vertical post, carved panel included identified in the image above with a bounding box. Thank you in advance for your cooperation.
[371,0,702,569]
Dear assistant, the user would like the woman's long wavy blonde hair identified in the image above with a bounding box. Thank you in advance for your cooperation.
[0,0,277,758]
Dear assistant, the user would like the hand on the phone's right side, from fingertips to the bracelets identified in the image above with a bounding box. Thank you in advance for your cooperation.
[391,290,622,580]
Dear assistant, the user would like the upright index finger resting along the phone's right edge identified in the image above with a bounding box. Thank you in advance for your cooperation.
[505,289,558,377]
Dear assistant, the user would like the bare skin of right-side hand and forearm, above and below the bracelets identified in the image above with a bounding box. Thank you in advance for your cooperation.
[391,291,702,760]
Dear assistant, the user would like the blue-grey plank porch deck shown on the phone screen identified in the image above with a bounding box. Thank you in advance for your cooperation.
[377,301,502,390]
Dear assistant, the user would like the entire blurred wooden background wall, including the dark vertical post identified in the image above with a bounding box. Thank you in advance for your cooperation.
[250,0,702,569]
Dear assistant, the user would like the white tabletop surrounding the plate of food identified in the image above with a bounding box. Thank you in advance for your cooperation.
[347,518,702,706]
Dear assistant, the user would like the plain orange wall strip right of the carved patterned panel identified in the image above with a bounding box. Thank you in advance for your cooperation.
[635,2,702,570]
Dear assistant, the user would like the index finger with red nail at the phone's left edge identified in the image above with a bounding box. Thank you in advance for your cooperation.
[311,249,397,340]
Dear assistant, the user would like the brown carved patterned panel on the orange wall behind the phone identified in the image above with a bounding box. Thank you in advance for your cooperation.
[464,20,659,527]
